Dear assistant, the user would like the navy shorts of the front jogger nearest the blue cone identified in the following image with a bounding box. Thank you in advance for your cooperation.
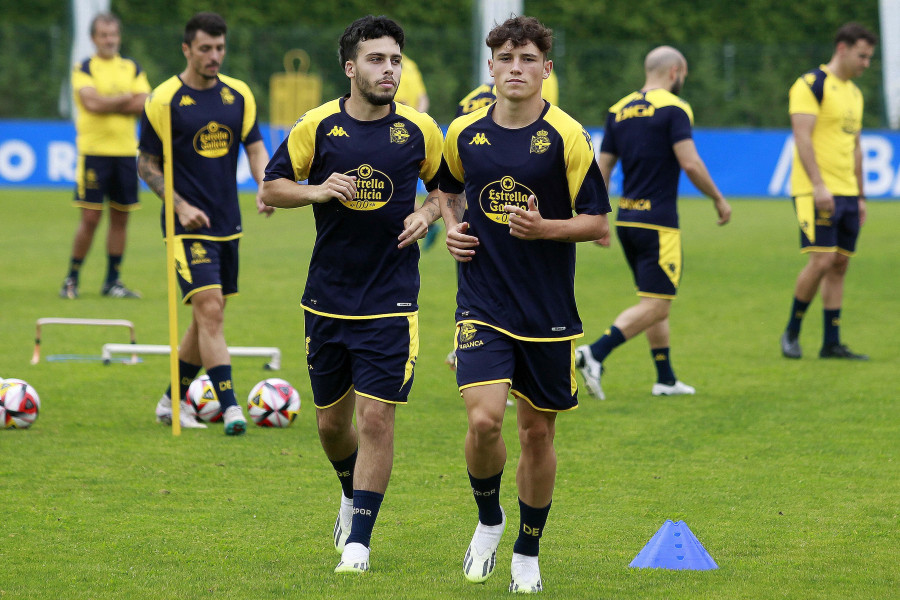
[456,321,578,412]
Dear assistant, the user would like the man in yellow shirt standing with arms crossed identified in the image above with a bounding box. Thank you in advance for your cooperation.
[59,13,150,299]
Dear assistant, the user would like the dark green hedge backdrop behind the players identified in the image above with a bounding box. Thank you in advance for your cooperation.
[0,0,887,128]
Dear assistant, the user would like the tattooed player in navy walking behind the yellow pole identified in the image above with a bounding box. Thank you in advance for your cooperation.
[138,12,274,435]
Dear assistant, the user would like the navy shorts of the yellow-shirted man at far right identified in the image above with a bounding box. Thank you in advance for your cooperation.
[794,196,859,256]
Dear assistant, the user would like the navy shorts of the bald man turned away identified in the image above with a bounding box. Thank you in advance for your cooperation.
[616,225,682,300]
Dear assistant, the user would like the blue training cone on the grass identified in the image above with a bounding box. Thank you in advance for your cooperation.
[628,519,719,571]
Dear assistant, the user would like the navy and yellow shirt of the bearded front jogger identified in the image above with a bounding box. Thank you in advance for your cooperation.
[265,98,443,318]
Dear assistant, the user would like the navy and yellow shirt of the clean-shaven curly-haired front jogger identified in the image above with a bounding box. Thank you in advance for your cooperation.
[441,102,610,340]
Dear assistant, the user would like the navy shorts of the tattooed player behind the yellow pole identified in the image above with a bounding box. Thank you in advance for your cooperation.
[175,236,239,304]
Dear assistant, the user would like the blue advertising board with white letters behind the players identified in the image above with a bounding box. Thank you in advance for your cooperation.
[0,120,900,198]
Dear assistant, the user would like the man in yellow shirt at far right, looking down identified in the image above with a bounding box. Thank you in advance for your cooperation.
[781,23,878,360]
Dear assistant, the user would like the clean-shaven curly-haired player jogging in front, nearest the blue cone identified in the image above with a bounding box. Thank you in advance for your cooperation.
[440,17,610,592]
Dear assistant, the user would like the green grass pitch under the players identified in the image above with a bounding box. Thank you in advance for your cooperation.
[0,190,900,600]
